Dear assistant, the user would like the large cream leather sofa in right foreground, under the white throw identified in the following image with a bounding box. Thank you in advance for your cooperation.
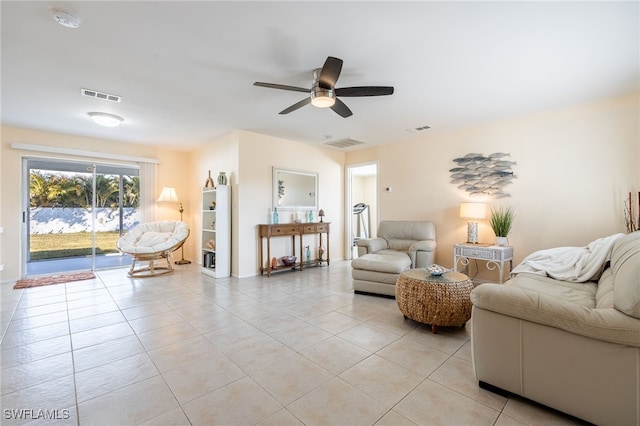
[471,231,640,426]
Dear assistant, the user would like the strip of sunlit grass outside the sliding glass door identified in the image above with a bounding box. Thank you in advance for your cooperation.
[30,232,120,260]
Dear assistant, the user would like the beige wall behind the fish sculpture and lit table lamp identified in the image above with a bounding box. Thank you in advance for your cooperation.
[346,95,640,278]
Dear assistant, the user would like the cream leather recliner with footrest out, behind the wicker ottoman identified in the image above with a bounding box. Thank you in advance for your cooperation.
[351,220,436,297]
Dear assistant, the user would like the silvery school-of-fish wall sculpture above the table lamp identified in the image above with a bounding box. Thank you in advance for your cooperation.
[449,152,517,198]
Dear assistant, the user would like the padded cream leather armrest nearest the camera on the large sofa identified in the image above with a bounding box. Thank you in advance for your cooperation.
[471,284,640,347]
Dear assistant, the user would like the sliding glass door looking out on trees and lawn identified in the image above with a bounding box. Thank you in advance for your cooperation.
[22,158,140,276]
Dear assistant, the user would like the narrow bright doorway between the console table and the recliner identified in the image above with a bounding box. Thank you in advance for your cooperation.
[345,162,378,260]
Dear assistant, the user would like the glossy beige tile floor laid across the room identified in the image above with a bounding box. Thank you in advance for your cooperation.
[0,261,592,426]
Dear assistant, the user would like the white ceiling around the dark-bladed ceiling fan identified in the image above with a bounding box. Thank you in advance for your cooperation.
[0,1,640,150]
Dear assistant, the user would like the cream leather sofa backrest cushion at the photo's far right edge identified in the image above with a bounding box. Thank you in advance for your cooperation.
[611,231,640,318]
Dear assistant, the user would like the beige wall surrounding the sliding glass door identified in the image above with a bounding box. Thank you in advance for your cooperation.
[0,126,194,281]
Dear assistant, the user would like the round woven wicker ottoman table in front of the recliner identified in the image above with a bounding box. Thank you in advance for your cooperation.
[396,269,473,333]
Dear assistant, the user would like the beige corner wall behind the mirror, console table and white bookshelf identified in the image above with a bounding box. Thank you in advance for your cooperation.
[192,131,344,277]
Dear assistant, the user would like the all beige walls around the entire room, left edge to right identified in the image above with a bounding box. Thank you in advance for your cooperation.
[0,95,640,281]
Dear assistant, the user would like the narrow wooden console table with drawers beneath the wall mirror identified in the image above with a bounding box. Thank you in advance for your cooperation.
[258,222,331,276]
